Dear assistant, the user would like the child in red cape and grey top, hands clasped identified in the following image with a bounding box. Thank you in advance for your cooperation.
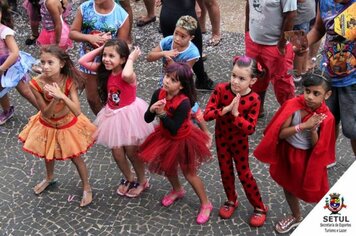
[254,74,335,233]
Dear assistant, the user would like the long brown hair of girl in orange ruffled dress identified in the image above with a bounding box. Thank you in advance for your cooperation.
[40,45,85,88]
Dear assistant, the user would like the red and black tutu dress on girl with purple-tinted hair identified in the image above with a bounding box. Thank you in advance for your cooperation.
[139,89,211,176]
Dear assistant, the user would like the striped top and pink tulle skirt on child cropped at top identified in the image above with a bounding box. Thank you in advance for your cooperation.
[37,0,73,49]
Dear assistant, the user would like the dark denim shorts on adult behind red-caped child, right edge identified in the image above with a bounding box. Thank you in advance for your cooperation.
[326,84,356,140]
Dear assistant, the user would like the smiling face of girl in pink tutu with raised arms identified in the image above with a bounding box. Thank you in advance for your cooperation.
[102,46,126,73]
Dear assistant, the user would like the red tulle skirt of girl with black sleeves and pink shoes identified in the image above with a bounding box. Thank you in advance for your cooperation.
[139,125,211,176]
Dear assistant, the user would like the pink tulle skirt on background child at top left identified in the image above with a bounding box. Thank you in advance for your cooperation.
[37,21,73,50]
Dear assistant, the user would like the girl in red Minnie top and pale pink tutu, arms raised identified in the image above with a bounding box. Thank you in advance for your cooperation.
[79,39,154,197]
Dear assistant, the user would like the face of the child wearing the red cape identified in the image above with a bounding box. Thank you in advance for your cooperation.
[304,85,331,110]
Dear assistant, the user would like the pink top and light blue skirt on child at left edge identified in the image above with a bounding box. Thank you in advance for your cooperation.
[0,24,36,97]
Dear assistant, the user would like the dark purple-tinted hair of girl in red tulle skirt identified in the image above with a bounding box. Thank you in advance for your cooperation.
[165,62,197,107]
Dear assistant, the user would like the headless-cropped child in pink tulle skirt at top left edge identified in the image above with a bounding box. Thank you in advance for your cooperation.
[37,0,73,49]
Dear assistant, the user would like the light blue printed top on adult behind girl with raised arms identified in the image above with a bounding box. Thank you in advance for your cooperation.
[79,0,128,74]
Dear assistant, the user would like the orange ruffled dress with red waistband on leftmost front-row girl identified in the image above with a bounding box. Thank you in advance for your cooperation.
[19,78,96,161]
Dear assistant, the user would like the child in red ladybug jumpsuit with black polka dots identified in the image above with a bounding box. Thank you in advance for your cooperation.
[204,56,267,227]
